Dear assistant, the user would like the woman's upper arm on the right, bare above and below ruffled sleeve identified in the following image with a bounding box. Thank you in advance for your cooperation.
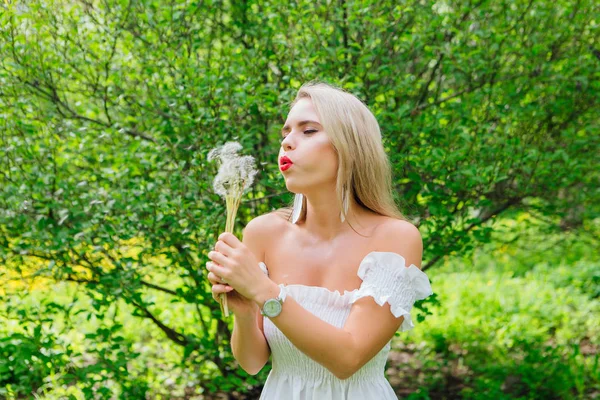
[344,221,423,376]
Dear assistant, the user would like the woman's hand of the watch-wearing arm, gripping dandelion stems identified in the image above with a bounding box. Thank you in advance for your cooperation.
[206,232,273,301]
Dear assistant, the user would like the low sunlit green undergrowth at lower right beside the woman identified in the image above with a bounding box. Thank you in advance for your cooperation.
[395,222,600,399]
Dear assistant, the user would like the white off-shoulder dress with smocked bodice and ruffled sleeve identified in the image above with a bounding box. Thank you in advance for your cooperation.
[255,251,433,400]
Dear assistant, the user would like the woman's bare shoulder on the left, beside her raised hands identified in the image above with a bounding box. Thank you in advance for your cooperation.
[242,212,288,261]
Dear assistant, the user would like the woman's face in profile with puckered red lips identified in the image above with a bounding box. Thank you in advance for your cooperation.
[277,98,338,193]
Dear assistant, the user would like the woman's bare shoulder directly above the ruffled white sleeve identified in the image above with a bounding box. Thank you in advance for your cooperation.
[375,218,423,268]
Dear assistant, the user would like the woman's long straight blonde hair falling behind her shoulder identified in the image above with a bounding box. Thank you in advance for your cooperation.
[276,81,407,233]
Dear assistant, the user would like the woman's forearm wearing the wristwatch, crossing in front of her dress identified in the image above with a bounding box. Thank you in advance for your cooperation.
[254,285,354,379]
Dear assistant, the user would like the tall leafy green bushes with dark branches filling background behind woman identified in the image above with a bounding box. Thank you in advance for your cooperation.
[0,0,600,398]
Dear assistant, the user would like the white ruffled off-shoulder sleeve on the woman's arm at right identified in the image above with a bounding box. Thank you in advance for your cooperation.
[350,251,433,331]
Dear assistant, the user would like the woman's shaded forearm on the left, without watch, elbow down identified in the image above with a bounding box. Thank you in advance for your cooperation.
[231,311,270,375]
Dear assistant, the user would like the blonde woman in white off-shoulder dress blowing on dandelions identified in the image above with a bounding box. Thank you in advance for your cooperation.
[207,79,432,400]
